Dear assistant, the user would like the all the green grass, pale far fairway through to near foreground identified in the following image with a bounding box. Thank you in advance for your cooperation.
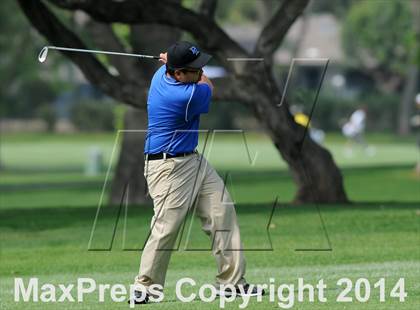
[0,133,420,310]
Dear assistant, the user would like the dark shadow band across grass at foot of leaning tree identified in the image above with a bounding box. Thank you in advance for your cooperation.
[0,201,420,231]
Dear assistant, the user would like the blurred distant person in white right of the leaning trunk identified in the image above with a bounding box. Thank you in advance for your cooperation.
[342,106,375,157]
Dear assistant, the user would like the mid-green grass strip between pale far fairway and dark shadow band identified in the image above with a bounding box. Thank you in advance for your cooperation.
[0,166,420,209]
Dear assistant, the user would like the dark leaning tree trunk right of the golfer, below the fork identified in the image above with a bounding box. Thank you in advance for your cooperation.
[243,68,349,203]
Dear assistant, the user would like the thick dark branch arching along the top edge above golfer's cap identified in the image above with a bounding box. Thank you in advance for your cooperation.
[48,0,249,72]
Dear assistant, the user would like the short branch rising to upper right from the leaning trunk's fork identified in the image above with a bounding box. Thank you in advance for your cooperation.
[254,0,309,60]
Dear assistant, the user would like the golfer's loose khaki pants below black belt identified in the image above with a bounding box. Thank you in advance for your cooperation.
[135,154,245,287]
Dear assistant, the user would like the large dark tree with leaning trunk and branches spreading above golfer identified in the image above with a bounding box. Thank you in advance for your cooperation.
[17,0,348,202]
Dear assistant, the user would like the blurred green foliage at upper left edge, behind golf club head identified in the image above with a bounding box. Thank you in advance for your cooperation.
[0,1,69,118]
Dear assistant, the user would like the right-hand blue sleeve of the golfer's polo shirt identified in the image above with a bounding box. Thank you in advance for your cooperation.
[185,83,211,122]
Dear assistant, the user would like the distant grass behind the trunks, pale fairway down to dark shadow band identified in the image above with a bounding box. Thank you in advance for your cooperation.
[0,132,420,208]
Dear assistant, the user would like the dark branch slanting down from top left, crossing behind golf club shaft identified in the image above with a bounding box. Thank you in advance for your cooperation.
[18,0,147,107]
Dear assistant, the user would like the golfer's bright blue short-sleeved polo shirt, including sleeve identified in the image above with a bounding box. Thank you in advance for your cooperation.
[144,65,211,155]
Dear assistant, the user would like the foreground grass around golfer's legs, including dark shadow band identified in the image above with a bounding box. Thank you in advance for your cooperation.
[0,204,420,309]
